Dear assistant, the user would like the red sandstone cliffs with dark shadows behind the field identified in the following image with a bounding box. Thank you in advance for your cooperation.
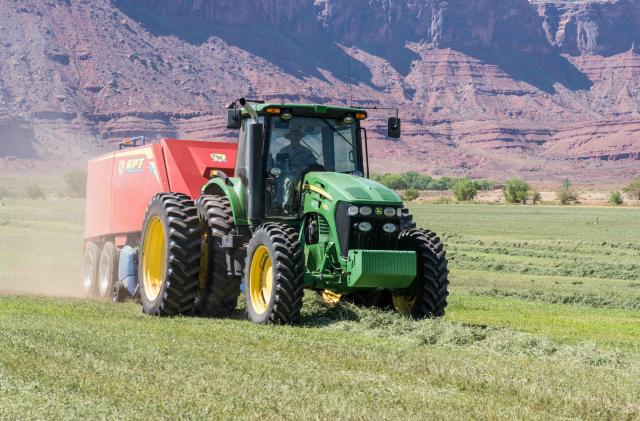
[0,0,640,183]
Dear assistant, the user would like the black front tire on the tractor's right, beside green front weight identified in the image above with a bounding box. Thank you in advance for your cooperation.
[393,229,449,319]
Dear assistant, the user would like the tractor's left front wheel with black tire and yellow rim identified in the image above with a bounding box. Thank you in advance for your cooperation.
[244,223,305,324]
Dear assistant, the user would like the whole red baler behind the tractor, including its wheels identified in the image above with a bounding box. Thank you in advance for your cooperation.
[83,139,237,301]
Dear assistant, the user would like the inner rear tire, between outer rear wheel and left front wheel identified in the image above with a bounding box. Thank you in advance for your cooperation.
[194,196,241,317]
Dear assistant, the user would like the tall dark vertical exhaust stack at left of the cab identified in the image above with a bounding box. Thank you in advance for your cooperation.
[246,122,264,225]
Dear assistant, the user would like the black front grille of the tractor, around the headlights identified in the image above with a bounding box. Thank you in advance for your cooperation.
[336,203,400,257]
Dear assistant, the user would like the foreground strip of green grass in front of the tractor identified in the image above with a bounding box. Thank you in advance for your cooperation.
[0,297,640,419]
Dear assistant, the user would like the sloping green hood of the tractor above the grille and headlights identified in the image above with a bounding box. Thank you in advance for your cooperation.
[305,172,402,205]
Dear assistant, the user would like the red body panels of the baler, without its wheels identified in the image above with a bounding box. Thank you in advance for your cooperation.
[84,139,237,247]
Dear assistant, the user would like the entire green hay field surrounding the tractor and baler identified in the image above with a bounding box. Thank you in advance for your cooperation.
[0,199,640,419]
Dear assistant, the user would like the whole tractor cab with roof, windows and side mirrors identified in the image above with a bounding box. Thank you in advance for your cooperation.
[227,99,400,220]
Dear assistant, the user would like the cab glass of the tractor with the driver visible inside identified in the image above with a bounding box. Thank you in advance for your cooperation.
[266,117,362,216]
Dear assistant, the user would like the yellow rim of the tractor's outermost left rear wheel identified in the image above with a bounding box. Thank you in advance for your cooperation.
[142,216,166,301]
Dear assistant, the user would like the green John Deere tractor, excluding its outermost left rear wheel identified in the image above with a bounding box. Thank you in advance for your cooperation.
[196,99,448,324]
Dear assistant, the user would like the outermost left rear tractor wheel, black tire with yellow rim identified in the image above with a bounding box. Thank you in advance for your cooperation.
[138,193,200,316]
